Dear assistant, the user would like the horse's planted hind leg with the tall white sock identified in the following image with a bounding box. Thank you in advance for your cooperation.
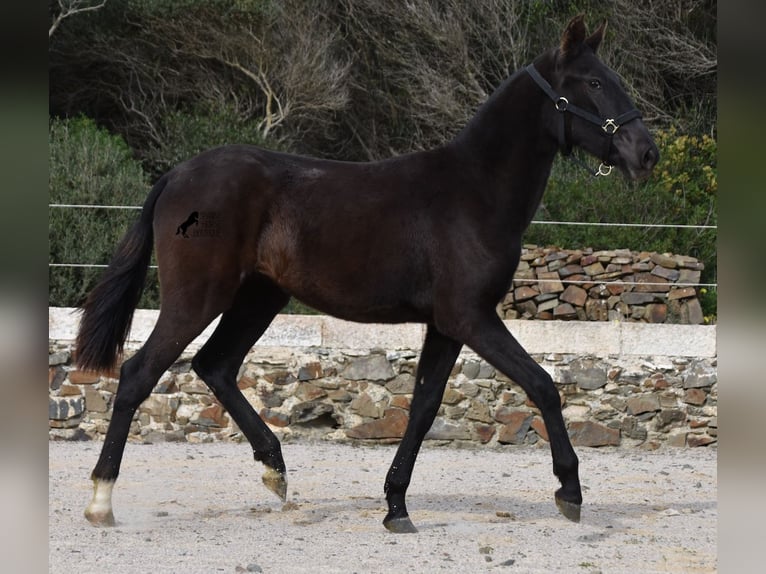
[85,310,219,526]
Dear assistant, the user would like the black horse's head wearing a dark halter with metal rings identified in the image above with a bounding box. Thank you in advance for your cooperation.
[530,16,659,179]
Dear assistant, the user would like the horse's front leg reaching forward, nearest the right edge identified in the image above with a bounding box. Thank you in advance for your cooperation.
[444,310,582,522]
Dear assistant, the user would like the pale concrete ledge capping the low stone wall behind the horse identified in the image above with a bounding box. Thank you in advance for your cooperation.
[48,307,717,358]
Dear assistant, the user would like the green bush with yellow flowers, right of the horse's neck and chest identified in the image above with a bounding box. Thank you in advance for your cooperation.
[524,128,718,320]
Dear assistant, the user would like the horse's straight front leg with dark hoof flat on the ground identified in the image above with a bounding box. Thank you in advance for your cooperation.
[383,325,462,533]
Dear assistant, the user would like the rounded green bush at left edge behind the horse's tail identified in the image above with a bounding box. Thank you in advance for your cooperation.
[48,117,158,307]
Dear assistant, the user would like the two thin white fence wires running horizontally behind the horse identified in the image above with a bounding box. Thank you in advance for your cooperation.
[48,203,718,289]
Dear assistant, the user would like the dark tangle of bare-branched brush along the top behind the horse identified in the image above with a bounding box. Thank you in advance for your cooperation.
[49,0,717,159]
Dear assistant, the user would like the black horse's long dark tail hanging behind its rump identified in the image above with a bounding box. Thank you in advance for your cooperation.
[75,177,167,371]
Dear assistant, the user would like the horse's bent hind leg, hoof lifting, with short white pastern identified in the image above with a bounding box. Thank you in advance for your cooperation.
[192,275,290,500]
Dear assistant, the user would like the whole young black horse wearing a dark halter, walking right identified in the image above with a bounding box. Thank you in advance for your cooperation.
[76,16,659,532]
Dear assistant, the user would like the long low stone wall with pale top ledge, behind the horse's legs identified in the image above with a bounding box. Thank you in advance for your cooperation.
[48,309,718,449]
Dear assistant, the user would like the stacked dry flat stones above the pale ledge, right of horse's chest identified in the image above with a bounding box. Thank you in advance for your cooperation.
[499,245,704,325]
